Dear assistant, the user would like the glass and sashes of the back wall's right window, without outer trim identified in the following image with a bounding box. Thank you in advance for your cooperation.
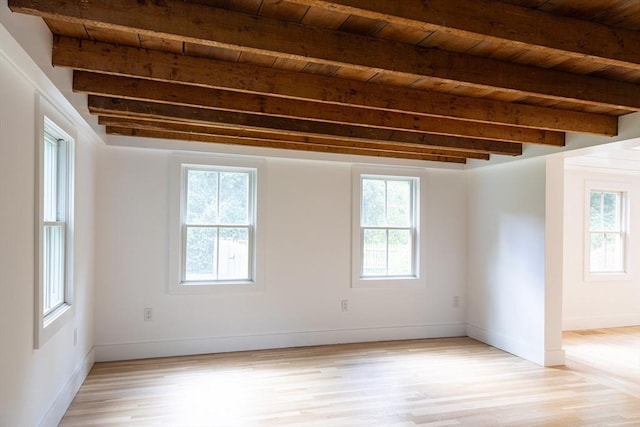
[360,175,418,278]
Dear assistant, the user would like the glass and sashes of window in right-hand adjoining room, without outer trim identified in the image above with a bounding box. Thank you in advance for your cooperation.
[589,190,626,273]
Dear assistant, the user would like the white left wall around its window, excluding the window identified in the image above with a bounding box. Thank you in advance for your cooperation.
[0,32,96,427]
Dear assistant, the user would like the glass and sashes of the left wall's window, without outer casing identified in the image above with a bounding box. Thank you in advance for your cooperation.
[41,121,69,321]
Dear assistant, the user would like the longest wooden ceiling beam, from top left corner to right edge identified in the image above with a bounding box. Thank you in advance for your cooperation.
[9,0,640,110]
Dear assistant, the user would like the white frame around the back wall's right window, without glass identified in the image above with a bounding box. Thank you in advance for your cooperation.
[351,165,426,288]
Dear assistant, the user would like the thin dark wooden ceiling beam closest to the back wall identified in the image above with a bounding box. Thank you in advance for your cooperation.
[107,126,466,164]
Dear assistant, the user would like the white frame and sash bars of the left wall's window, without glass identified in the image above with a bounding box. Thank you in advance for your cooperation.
[34,106,75,349]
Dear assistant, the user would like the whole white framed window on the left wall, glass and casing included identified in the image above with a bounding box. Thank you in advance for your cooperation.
[35,116,74,348]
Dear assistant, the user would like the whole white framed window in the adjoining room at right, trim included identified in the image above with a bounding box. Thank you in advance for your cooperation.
[585,183,629,280]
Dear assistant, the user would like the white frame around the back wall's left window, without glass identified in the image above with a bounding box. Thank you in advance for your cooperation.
[167,154,266,294]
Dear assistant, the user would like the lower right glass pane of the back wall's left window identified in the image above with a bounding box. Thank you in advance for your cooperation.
[218,227,249,280]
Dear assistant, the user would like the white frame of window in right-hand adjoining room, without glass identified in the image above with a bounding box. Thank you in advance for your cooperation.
[583,181,632,282]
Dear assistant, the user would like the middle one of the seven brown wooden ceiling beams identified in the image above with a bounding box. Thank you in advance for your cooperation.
[73,71,564,146]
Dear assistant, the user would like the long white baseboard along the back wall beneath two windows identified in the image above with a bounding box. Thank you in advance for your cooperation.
[95,323,466,362]
